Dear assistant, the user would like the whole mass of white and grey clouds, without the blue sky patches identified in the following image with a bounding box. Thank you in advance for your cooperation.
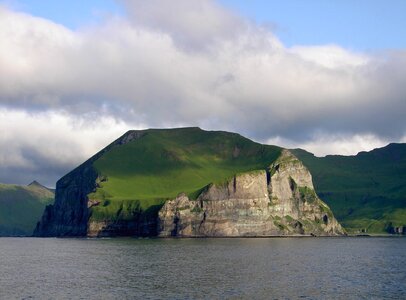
[0,0,406,184]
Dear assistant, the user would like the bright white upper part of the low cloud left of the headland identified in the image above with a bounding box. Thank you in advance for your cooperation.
[0,109,137,167]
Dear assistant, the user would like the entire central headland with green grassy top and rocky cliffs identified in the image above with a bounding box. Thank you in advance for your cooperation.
[35,128,342,236]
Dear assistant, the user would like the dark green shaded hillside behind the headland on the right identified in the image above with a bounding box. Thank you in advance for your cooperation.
[293,144,406,233]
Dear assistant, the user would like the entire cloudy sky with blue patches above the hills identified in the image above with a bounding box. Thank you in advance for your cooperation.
[0,0,406,187]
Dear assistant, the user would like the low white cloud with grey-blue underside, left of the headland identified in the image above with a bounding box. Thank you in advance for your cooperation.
[0,109,139,186]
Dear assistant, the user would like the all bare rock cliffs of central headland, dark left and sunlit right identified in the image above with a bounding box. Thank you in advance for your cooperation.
[34,131,344,237]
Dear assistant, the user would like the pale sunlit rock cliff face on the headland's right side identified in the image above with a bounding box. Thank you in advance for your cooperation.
[158,150,344,237]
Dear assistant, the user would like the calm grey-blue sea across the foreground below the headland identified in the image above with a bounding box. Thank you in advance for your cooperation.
[0,238,406,299]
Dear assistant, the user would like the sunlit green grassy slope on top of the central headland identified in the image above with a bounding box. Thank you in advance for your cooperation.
[89,128,281,218]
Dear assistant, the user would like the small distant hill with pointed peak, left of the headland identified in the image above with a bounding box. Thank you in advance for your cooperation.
[0,181,54,236]
